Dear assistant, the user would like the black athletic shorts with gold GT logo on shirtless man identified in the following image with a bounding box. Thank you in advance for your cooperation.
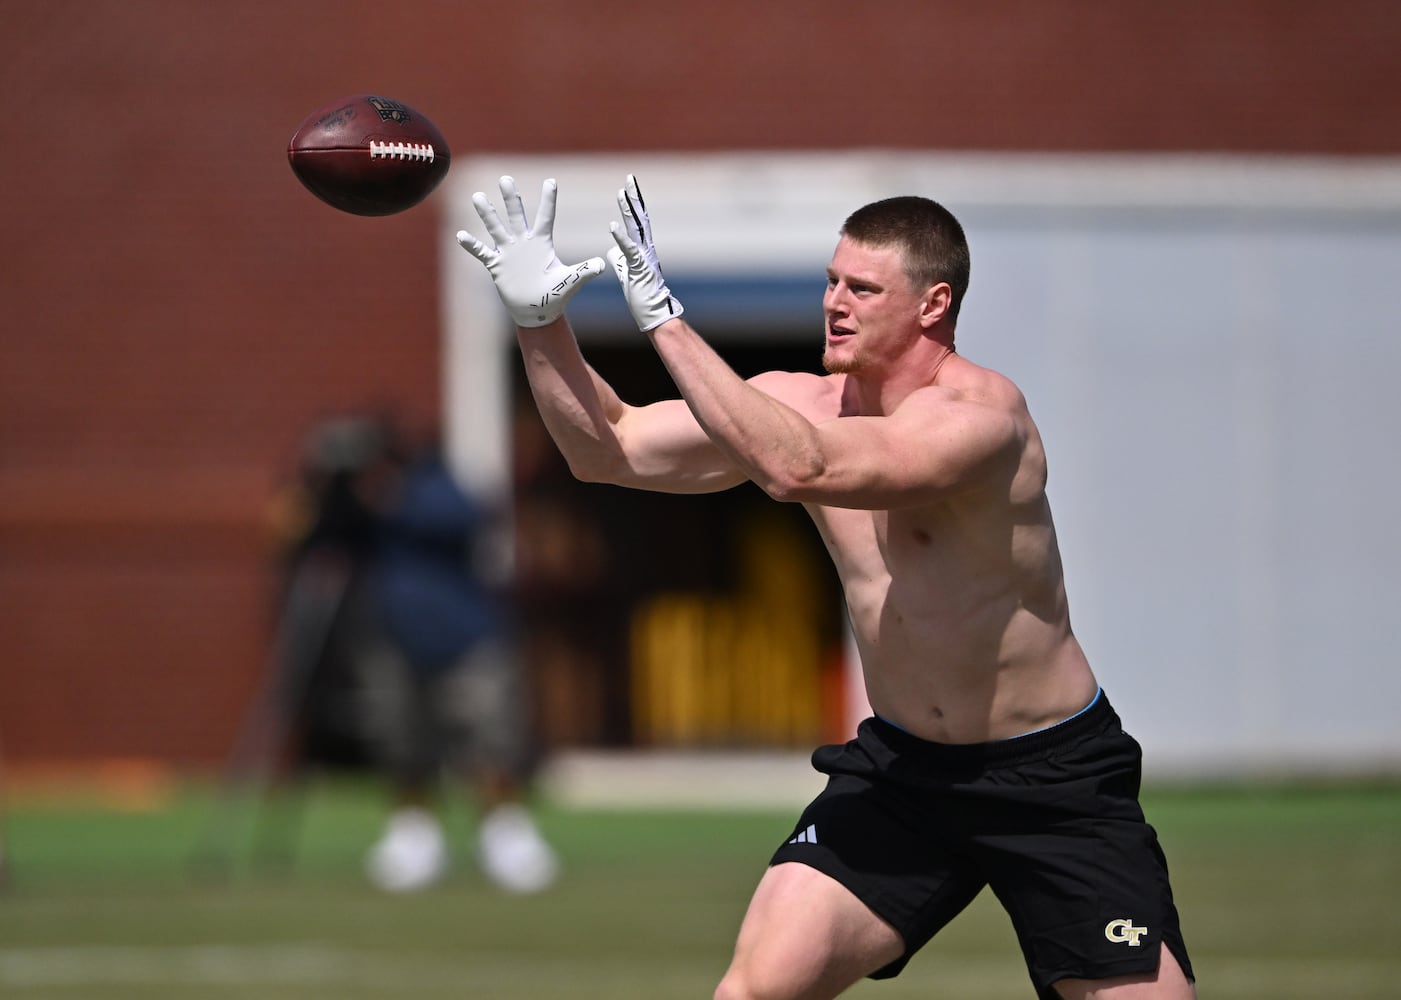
[772,692,1194,997]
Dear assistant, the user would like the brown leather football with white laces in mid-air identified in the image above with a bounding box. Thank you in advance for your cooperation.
[287,94,451,216]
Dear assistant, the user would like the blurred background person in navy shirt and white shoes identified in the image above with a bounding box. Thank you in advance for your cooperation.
[356,417,559,894]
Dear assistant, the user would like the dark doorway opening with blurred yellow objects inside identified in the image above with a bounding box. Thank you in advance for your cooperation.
[513,332,843,746]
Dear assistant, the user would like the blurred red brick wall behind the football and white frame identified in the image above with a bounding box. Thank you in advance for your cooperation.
[0,0,1401,763]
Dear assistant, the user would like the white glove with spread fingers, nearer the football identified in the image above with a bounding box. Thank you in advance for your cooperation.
[457,176,604,326]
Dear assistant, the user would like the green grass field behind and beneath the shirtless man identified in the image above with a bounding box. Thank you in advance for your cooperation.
[0,782,1401,1000]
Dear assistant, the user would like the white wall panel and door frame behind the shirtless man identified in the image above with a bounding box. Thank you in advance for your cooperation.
[443,151,1401,775]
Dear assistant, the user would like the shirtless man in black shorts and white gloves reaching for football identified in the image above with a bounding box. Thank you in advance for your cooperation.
[458,176,1195,1000]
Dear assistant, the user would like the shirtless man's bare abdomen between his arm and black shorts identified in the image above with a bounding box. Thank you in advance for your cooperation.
[814,510,1098,744]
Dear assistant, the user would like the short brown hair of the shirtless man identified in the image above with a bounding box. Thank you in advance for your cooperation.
[842,195,972,329]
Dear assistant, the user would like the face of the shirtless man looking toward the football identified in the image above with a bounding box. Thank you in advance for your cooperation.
[822,237,920,374]
